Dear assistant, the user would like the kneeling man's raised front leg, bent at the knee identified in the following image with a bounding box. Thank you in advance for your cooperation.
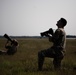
[38,48,54,70]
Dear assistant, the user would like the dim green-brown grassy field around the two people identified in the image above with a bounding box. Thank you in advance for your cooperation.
[0,38,76,75]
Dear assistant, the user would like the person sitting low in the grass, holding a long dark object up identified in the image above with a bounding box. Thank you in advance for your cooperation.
[0,39,18,55]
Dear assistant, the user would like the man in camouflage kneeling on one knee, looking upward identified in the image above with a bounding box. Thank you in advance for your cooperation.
[38,18,67,71]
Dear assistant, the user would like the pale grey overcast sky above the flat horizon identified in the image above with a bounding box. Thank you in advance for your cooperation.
[0,0,76,36]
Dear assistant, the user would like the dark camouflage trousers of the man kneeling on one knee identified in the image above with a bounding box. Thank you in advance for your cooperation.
[38,47,64,70]
